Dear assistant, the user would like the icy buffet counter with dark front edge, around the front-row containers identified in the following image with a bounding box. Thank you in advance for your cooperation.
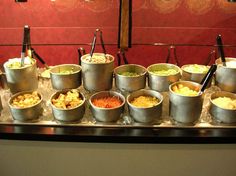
[0,79,236,143]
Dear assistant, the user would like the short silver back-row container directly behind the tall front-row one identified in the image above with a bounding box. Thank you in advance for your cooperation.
[181,64,211,85]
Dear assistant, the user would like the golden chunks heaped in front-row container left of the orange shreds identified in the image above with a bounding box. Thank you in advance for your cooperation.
[52,89,83,109]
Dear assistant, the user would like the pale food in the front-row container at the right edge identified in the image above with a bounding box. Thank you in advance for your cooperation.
[212,97,236,110]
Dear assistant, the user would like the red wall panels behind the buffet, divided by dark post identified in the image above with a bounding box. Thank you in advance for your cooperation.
[0,0,236,66]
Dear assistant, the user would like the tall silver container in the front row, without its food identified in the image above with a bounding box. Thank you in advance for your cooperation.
[169,81,203,123]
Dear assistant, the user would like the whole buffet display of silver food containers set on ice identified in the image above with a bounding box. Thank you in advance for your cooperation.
[0,26,236,128]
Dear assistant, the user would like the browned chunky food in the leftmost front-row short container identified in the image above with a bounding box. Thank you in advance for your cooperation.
[11,91,41,108]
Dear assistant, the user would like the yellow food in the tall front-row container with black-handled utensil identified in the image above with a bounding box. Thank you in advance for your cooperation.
[172,84,198,96]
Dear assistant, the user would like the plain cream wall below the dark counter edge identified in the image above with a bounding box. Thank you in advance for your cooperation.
[0,140,236,176]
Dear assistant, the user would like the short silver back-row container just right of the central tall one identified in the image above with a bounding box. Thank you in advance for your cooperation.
[114,64,147,92]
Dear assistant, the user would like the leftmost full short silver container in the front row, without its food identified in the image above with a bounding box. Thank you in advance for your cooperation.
[8,91,43,122]
